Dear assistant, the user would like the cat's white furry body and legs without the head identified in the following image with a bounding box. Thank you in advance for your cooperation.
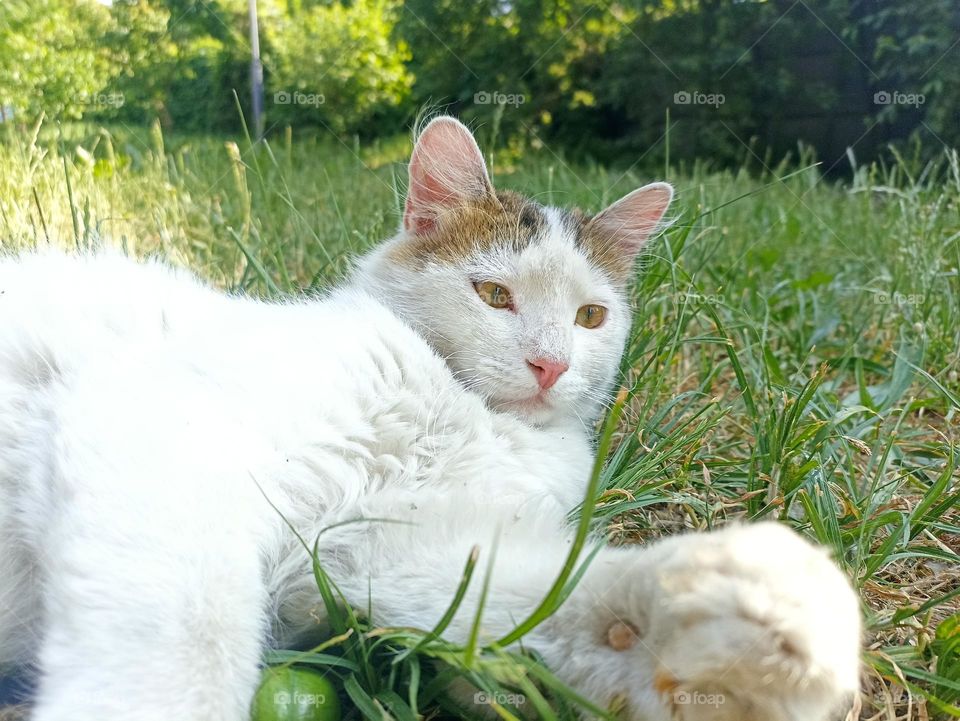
[0,249,859,721]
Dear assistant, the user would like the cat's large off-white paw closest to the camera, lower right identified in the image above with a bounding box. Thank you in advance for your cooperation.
[624,523,860,721]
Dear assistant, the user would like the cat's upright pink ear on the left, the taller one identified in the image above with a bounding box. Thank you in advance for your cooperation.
[403,116,493,234]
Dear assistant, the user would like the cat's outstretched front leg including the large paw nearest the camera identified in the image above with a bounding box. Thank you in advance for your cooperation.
[316,510,860,721]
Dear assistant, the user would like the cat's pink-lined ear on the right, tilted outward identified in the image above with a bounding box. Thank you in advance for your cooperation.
[589,183,673,263]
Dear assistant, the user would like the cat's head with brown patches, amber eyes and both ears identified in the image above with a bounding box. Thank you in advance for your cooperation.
[358,117,673,425]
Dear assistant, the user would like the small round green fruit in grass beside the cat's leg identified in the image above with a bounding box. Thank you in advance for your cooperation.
[250,666,340,721]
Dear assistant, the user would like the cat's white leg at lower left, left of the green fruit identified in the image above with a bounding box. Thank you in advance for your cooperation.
[23,361,282,721]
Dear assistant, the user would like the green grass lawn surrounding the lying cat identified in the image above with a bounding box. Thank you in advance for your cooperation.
[0,121,960,721]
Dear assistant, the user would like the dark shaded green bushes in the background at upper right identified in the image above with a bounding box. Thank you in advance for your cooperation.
[398,0,960,167]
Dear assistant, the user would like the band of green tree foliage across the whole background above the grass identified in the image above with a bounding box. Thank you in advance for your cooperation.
[0,0,960,165]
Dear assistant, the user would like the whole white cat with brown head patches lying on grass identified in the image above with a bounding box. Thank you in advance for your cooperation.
[0,118,860,721]
